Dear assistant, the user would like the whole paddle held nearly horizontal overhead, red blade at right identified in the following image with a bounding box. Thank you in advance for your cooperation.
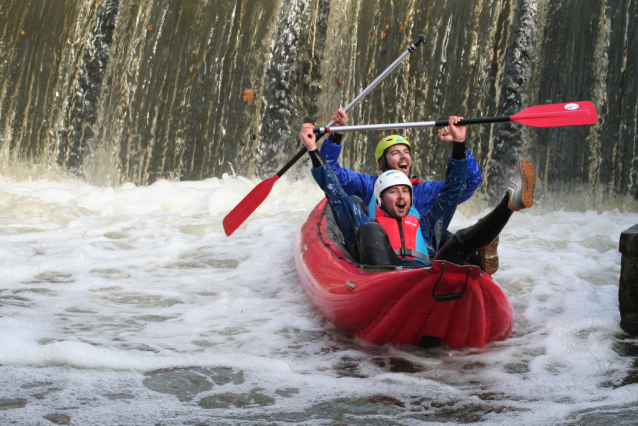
[313,101,598,134]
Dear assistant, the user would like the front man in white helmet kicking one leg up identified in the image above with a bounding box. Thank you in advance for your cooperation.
[299,117,536,266]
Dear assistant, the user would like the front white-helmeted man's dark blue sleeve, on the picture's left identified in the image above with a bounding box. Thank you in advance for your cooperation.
[312,164,371,247]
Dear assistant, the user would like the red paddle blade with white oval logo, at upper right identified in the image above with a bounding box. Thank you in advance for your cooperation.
[510,101,598,127]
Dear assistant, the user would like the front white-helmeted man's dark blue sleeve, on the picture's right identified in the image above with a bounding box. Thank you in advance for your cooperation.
[421,158,468,257]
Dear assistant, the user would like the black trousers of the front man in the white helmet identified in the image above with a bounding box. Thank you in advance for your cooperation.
[357,194,512,266]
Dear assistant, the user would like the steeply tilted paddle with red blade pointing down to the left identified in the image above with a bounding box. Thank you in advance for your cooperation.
[223,34,425,236]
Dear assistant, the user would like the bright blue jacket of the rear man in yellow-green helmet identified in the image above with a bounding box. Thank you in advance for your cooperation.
[320,140,483,214]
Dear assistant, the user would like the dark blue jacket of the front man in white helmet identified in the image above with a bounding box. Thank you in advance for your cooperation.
[312,154,468,259]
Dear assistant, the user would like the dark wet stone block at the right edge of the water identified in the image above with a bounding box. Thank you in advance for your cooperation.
[618,225,638,336]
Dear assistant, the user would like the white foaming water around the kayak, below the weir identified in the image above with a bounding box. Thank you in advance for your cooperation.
[0,172,638,425]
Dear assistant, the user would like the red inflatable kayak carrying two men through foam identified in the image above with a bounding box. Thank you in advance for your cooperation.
[295,199,514,348]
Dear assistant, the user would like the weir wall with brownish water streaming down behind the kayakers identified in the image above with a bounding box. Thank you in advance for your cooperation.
[0,0,638,209]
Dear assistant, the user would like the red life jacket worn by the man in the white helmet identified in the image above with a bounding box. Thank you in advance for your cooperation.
[374,210,430,265]
